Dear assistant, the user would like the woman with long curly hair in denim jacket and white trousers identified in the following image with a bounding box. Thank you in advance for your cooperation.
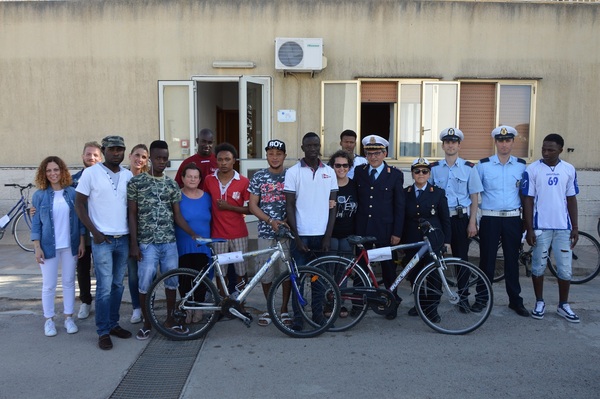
[31,156,85,337]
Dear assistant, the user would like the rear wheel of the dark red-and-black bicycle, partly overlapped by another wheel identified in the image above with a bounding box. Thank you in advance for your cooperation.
[308,256,372,332]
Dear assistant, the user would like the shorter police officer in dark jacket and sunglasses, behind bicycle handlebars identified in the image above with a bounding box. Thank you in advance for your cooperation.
[402,158,452,323]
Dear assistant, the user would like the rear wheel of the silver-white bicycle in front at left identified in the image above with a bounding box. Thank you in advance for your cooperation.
[145,269,221,341]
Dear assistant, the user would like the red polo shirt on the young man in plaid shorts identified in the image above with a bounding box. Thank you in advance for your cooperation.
[204,172,250,240]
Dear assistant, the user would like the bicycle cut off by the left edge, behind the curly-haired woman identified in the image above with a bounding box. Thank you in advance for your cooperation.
[0,183,33,252]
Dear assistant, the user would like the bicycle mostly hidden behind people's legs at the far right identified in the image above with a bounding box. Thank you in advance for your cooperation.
[469,231,600,284]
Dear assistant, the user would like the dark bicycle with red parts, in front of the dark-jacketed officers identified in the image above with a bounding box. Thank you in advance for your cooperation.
[308,223,493,335]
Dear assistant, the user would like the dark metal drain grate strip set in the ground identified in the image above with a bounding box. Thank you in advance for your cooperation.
[110,334,204,399]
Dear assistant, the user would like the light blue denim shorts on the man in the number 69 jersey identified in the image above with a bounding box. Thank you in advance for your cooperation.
[531,230,573,281]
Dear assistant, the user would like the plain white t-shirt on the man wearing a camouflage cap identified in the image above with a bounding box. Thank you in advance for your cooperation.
[75,163,133,235]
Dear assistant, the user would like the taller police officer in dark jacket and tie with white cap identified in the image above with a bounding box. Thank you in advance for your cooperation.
[354,134,404,319]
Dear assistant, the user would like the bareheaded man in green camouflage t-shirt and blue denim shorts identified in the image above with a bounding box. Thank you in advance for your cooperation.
[127,140,196,340]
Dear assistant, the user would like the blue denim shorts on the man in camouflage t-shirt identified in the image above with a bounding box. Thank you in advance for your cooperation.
[138,242,179,294]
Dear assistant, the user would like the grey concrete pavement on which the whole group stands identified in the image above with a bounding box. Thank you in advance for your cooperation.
[0,245,600,398]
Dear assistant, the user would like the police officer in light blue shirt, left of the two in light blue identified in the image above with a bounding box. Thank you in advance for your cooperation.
[429,127,483,313]
